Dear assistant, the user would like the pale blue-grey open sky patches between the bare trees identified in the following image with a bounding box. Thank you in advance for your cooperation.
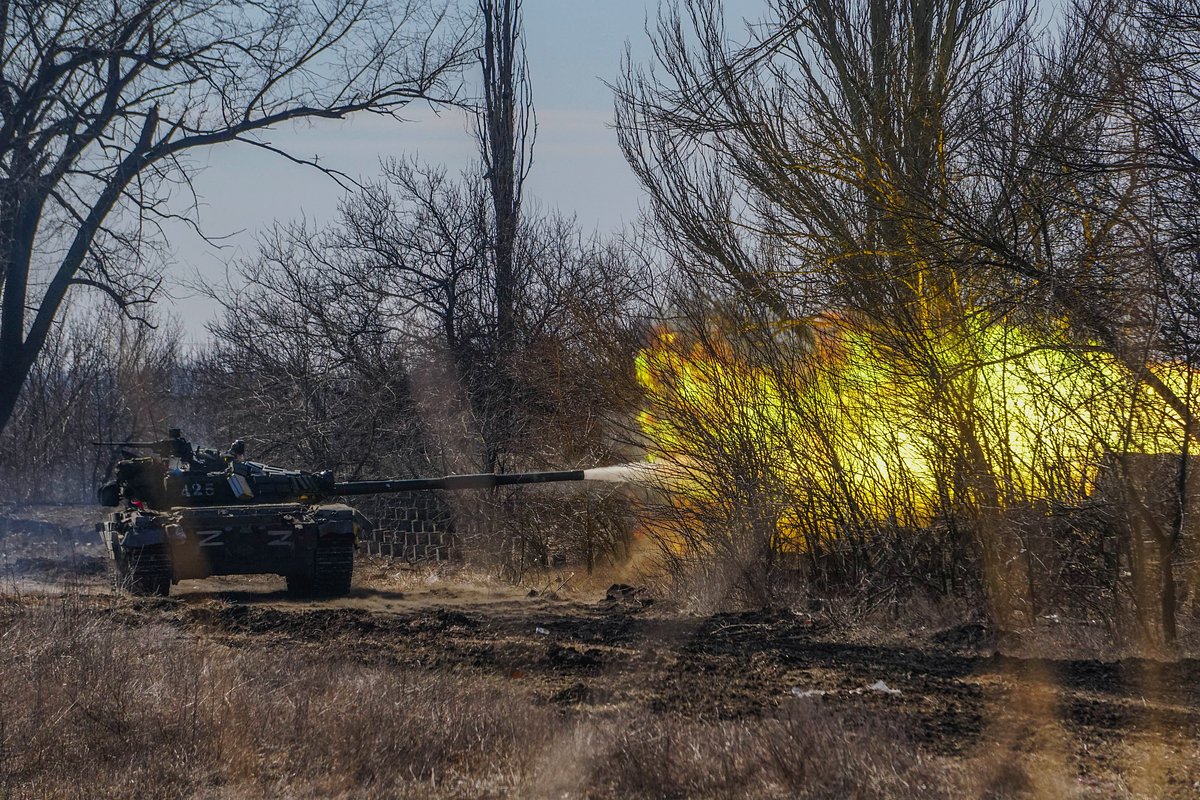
[168,0,764,341]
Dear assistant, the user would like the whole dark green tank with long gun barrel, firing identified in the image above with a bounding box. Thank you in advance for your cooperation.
[95,428,583,597]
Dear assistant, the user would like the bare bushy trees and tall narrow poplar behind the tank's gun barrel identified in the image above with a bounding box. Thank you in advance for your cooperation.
[196,0,641,575]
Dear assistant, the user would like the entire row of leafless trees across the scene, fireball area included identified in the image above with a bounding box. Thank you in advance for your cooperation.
[0,0,1200,642]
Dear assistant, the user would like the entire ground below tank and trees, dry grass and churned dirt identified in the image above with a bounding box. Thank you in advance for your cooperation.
[0,513,1200,798]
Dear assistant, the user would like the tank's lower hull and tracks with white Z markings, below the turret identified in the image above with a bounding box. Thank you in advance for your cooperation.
[100,503,366,596]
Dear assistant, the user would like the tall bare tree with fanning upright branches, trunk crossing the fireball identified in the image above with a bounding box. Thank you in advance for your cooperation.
[617,0,1046,620]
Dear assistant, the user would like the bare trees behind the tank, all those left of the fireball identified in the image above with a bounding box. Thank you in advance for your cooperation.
[0,0,643,572]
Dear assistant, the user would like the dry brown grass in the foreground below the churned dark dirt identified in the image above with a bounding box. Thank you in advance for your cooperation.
[0,594,1022,798]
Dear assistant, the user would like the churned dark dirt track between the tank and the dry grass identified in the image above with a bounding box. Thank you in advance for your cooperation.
[5,510,1200,798]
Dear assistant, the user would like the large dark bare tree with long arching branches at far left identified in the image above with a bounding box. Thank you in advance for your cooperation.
[0,0,466,438]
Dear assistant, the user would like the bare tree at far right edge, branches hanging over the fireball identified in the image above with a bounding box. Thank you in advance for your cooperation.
[926,0,1200,644]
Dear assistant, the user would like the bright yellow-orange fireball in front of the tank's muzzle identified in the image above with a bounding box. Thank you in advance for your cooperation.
[636,314,1196,546]
